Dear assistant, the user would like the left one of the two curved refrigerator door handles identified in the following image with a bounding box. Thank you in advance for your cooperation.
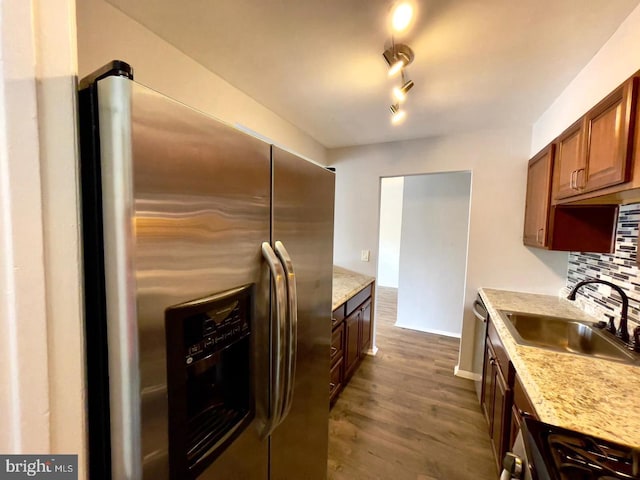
[261,242,287,438]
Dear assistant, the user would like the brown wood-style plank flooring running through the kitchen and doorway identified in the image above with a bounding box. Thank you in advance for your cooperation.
[328,287,498,480]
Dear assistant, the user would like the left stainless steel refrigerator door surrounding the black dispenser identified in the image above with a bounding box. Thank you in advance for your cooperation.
[98,77,271,480]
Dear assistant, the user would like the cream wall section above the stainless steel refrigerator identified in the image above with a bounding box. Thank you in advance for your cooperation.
[77,0,326,165]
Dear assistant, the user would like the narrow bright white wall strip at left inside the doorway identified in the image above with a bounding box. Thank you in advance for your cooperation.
[378,177,404,288]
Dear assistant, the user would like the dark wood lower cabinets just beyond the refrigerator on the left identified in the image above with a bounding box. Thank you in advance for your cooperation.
[329,284,375,406]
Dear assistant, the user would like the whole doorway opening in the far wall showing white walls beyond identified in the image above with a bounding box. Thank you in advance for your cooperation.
[377,171,471,344]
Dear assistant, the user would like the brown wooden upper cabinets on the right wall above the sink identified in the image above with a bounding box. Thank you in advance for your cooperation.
[523,72,640,253]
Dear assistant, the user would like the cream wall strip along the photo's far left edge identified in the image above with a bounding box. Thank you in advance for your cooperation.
[0,2,50,453]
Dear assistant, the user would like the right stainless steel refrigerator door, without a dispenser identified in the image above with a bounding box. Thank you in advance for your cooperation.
[270,147,335,480]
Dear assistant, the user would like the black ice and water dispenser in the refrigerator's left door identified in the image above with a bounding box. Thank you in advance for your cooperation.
[165,284,255,479]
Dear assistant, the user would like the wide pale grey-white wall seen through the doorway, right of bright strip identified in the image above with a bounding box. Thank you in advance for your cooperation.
[396,172,471,337]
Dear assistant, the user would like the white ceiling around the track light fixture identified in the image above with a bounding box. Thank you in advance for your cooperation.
[107,0,640,148]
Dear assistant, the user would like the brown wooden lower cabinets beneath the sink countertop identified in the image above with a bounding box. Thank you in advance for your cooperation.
[480,318,537,471]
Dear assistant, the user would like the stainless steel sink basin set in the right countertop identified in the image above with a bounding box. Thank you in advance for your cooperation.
[500,311,640,363]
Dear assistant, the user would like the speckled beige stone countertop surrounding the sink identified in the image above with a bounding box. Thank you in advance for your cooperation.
[480,288,640,448]
